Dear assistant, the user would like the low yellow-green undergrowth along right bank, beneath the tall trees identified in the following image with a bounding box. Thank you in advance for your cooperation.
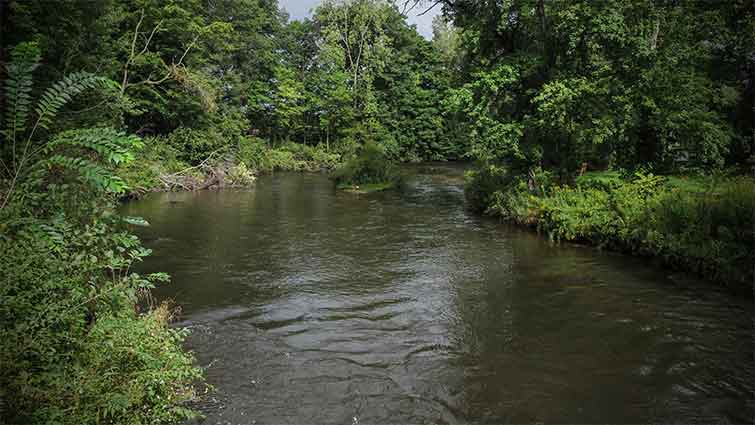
[466,166,755,296]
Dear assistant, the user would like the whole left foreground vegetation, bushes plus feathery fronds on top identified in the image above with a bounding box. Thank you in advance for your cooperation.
[0,43,201,424]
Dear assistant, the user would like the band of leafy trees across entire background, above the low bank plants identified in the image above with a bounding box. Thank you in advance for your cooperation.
[3,0,755,172]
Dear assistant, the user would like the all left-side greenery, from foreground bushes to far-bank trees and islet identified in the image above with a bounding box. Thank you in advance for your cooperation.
[0,0,465,424]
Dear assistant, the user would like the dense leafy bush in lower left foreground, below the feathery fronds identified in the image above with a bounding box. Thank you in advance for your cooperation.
[0,214,201,424]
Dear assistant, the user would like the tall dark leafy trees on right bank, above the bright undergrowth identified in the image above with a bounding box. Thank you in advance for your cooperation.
[442,0,755,174]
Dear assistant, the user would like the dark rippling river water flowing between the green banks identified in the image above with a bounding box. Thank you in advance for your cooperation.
[125,167,755,425]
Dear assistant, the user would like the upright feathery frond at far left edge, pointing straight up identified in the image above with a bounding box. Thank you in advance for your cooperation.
[3,42,41,143]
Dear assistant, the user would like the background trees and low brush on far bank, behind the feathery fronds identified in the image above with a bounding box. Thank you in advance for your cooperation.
[3,0,465,194]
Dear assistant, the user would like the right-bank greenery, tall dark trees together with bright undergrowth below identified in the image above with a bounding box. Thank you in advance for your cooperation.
[443,0,755,289]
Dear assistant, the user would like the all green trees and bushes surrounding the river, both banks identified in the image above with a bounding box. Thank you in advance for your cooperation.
[0,0,755,425]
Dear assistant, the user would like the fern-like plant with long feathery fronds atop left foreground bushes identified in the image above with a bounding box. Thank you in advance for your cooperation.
[0,43,141,210]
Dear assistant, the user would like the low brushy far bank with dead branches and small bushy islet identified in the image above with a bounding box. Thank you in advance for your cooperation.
[118,138,420,199]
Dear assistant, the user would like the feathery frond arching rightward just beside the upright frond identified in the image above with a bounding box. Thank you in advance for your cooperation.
[36,72,109,129]
